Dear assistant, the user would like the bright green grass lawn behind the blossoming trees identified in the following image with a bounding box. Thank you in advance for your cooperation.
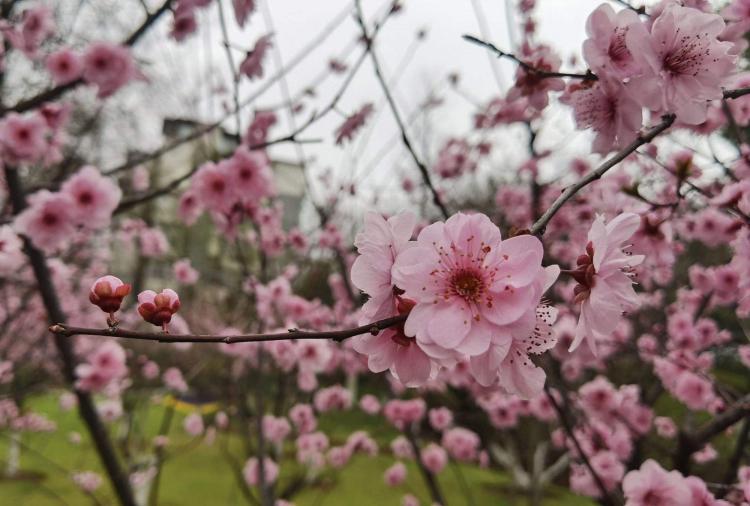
[0,395,592,506]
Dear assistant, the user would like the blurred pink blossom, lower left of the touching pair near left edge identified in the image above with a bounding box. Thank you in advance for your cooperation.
[13,190,75,252]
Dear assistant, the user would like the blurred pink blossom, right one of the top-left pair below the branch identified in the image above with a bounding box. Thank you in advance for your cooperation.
[83,42,138,98]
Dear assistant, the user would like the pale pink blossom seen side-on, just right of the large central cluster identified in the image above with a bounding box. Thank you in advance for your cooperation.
[570,213,644,353]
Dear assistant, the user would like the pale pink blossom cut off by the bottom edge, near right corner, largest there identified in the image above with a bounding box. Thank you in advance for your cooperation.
[622,459,691,506]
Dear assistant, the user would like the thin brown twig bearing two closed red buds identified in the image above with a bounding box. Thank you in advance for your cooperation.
[49,315,407,344]
